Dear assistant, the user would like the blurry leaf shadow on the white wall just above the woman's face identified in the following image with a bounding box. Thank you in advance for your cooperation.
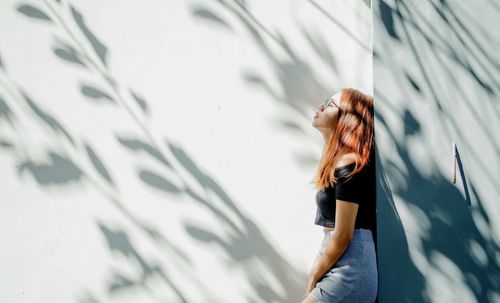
[190,0,371,167]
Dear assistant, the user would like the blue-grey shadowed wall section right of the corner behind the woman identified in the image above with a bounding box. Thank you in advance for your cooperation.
[373,0,500,303]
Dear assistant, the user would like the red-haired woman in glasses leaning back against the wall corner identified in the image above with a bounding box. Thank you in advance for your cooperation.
[302,88,378,303]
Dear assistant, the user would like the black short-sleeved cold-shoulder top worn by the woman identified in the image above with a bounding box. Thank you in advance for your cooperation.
[314,153,376,233]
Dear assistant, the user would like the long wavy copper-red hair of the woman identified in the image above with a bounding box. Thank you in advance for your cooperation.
[313,87,375,190]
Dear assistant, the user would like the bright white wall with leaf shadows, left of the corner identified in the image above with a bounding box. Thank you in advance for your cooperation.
[0,0,372,302]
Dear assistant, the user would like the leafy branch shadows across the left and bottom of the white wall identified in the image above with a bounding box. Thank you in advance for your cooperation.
[0,1,320,302]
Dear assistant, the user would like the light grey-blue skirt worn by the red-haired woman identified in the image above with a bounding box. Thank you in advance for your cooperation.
[308,228,378,303]
